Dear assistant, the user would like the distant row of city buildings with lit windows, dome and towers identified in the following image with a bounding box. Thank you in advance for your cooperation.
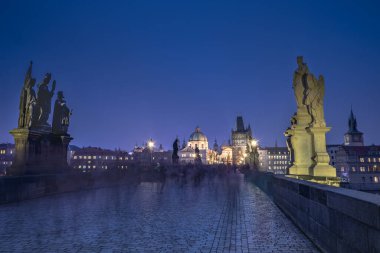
[0,111,380,189]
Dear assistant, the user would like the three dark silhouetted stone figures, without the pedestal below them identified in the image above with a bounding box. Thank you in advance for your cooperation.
[18,62,72,134]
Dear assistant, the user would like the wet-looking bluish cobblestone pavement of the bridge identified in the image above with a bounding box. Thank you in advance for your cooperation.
[0,175,318,253]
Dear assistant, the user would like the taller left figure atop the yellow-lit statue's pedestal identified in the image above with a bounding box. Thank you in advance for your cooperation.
[293,56,309,107]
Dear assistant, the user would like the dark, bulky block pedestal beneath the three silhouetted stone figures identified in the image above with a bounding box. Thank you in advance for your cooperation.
[7,128,72,176]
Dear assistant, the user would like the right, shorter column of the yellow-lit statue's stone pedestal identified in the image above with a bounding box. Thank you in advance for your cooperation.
[308,126,336,177]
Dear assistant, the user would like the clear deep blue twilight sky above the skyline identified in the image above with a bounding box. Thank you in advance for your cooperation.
[0,0,380,149]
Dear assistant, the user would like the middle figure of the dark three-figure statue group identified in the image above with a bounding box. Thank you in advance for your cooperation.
[36,73,56,126]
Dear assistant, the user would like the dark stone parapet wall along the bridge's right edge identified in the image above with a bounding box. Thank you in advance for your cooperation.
[254,173,380,253]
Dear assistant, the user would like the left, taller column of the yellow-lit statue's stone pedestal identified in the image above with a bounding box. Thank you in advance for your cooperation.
[289,107,313,175]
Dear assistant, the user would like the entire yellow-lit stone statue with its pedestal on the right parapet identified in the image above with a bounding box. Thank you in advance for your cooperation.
[285,56,336,177]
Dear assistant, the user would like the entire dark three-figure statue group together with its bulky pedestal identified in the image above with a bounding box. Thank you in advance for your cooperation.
[7,63,72,176]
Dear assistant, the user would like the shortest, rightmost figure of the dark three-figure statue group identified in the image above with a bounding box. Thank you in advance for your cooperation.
[52,91,72,134]
